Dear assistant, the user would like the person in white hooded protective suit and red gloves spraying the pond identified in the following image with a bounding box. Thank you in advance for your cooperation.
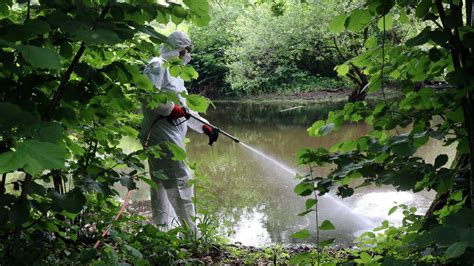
[140,31,218,232]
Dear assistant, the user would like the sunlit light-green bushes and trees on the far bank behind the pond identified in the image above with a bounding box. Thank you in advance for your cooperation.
[191,0,416,100]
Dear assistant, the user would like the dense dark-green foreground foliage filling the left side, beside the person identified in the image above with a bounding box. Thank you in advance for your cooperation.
[0,0,210,265]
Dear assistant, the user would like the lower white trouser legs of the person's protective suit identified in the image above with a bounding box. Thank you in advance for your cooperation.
[150,178,196,232]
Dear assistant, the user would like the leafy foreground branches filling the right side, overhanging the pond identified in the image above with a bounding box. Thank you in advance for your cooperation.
[295,0,474,265]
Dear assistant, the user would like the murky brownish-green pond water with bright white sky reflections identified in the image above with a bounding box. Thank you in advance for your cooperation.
[120,103,453,245]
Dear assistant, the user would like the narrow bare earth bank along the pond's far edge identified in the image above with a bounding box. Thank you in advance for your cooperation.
[211,88,402,103]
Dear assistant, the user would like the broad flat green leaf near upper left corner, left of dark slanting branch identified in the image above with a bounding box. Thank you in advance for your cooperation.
[18,45,61,70]
